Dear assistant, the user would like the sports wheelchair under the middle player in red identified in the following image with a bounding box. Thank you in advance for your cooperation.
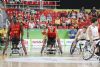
[43,40,61,55]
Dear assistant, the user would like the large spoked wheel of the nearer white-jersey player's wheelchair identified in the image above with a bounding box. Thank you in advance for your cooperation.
[82,44,95,60]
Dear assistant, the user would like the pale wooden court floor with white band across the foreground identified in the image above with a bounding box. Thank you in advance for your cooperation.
[0,53,100,67]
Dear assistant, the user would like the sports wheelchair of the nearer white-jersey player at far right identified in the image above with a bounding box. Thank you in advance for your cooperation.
[83,39,100,62]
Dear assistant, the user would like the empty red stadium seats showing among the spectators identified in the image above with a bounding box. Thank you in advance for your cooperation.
[6,9,93,29]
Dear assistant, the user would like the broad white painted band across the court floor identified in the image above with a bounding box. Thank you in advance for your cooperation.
[5,57,98,63]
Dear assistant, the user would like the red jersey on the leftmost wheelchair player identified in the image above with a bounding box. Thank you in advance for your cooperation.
[10,23,21,38]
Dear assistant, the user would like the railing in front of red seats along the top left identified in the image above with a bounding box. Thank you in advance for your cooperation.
[3,0,60,9]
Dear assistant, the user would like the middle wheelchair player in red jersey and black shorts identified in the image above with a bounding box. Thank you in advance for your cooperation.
[41,25,62,54]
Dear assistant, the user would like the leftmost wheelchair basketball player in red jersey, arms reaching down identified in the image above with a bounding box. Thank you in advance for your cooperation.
[3,18,27,55]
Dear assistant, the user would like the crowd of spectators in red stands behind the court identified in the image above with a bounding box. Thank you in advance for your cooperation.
[6,7,100,29]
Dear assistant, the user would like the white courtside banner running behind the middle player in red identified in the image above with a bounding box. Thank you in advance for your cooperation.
[24,39,73,52]
